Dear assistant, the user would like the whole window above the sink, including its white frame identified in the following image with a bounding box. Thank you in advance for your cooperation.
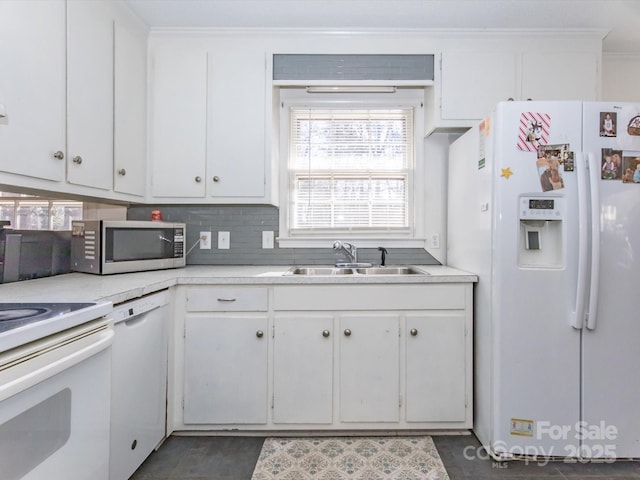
[280,90,423,246]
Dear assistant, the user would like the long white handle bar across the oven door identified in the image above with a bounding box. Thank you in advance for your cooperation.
[0,327,113,402]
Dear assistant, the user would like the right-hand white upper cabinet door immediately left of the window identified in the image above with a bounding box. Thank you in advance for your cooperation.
[207,52,266,201]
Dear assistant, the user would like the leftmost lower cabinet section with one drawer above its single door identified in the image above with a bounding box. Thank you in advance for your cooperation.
[184,287,269,425]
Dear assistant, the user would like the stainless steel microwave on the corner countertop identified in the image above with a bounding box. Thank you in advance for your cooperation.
[71,220,185,275]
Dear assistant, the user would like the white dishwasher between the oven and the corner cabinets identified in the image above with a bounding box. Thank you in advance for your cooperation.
[109,290,170,480]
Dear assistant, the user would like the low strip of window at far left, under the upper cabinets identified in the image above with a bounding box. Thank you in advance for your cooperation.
[0,192,82,230]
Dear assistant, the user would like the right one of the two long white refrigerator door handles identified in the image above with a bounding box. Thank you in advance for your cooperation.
[587,153,600,330]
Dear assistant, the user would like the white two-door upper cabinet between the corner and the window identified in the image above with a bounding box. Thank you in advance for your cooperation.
[149,37,270,203]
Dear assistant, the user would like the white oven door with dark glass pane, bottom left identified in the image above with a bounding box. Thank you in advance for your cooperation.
[0,322,113,480]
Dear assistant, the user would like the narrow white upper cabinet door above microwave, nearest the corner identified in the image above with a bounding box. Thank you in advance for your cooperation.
[113,21,147,196]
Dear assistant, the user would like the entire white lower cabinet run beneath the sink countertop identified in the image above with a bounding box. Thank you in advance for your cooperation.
[177,283,473,431]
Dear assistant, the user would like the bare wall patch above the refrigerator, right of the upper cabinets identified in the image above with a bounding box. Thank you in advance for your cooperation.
[602,54,640,102]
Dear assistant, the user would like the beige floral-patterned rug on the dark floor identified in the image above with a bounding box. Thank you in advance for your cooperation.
[251,436,449,480]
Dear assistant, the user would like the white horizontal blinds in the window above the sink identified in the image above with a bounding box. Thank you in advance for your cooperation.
[289,109,413,231]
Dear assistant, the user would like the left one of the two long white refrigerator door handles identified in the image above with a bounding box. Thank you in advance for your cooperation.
[571,152,589,329]
